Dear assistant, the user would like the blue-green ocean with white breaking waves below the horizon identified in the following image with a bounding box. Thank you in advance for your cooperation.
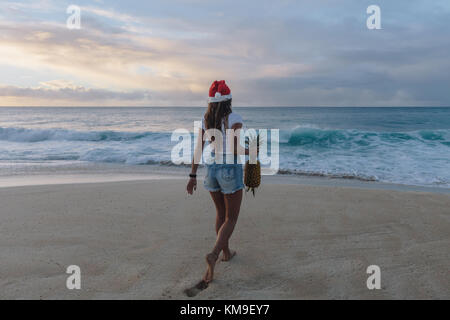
[0,107,450,188]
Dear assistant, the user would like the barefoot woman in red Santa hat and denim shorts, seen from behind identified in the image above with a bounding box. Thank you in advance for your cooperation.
[187,80,248,283]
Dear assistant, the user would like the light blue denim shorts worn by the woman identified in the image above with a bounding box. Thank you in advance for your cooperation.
[203,163,244,194]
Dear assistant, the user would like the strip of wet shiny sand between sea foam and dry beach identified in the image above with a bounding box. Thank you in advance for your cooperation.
[0,163,450,194]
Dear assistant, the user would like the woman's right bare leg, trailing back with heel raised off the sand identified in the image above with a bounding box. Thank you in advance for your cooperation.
[203,190,242,283]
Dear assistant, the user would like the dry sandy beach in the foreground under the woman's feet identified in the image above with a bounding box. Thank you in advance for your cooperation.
[0,180,450,299]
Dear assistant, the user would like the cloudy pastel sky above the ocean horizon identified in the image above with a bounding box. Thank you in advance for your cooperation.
[0,0,450,107]
